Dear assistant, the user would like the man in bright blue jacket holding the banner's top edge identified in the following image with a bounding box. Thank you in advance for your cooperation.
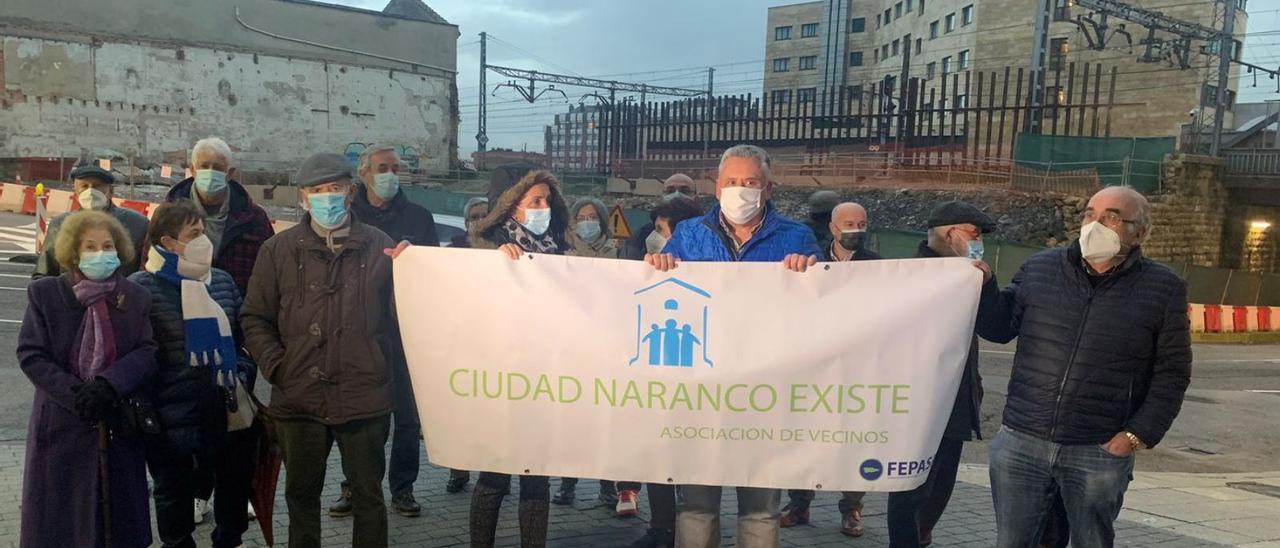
[645,145,822,548]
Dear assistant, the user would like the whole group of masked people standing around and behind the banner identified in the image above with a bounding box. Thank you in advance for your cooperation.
[18,138,1190,548]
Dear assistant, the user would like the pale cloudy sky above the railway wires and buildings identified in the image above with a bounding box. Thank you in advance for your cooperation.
[328,0,1280,157]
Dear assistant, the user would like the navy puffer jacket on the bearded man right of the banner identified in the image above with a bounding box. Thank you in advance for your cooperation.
[978,243,1192,446]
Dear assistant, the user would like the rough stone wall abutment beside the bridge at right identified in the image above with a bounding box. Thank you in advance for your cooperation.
[1143,155,1228,266]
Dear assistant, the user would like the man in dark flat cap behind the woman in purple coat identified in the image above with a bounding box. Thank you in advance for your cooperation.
[31,164,147,278]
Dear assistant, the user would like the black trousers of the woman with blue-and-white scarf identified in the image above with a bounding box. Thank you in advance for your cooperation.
[146,424,260,548]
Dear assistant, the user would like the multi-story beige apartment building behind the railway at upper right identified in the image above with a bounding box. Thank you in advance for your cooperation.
[764,0,1248,143]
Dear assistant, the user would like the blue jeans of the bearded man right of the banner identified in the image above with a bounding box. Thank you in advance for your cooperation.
[991,428,1133,548]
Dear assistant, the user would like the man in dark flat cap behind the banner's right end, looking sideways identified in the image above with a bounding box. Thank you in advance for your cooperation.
[888,201,996,548]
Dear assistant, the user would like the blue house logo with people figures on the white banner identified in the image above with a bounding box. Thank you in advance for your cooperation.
[627,278,714,367]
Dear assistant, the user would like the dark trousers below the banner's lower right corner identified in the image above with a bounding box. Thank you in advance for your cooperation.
[888,438,964,548]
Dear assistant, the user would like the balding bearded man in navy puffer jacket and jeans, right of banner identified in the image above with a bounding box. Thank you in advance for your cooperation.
[978,187,1192,547]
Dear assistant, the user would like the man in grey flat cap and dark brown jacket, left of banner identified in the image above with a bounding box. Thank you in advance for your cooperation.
[241,154,403,547]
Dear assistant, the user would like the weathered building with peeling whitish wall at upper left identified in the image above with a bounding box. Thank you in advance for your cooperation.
[0,0,458,179]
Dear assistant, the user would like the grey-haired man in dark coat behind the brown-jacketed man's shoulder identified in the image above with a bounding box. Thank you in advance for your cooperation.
[329,146,440,517]
